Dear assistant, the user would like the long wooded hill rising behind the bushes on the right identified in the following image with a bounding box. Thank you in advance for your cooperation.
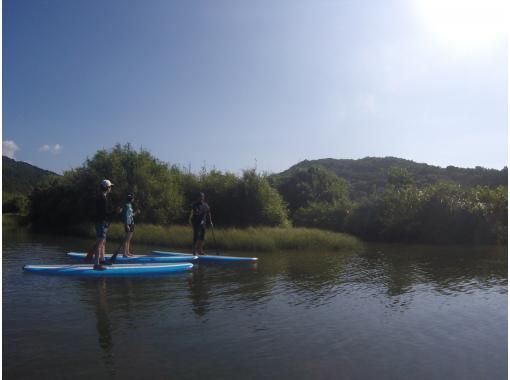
[272,157,508,199]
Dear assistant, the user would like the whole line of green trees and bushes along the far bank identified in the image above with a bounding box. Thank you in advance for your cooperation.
[25,144,508,243]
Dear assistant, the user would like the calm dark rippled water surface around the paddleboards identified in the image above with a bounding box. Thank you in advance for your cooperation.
[2,232,508,379]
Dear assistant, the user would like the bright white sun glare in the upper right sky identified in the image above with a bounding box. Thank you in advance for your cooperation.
[417,0,509,50]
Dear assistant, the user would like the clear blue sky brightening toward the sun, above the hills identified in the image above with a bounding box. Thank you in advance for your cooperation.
[2,0,508,173]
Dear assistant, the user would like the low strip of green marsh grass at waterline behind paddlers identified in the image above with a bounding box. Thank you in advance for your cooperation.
[2,214,361,252]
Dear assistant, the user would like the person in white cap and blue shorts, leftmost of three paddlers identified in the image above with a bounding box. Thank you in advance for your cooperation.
[94,179,114,270]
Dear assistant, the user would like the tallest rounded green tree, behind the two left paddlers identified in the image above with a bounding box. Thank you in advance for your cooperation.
[30,144,184,228]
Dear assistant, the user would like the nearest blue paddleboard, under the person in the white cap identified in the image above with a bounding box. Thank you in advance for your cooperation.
[23,263,193,277]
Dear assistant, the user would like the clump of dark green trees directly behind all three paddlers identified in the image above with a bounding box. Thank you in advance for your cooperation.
[30,144,289,230]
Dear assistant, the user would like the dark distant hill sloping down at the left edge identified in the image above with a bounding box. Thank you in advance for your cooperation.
[2,156,58,195]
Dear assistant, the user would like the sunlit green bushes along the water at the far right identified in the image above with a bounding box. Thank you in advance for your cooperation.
[346,182,508,244]
